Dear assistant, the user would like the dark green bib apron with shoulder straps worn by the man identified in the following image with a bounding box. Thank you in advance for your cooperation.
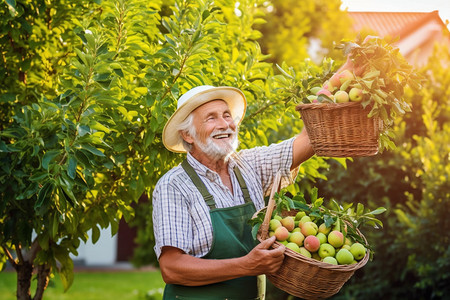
[163,160,259,300]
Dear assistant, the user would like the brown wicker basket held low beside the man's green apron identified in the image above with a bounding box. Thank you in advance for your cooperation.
[257,210,369,300]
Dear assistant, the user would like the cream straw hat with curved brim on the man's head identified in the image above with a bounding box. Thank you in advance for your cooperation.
[162,85,247,153]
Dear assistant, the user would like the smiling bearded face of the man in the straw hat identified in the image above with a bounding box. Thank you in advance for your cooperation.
[193,100,238,159]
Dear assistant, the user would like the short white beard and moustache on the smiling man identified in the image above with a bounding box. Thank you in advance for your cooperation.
[195,129,239,160]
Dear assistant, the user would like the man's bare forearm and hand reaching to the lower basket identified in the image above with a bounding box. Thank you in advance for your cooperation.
[159,237,285,286]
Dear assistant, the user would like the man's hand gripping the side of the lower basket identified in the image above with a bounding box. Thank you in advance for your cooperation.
[244,236,286,275]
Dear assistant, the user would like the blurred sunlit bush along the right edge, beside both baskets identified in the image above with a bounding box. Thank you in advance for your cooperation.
[319,41,450,299]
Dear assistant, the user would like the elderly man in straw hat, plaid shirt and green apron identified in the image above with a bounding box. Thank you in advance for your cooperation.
[153,86,314,299]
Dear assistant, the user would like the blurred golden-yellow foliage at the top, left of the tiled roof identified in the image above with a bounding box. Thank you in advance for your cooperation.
[257,0,353,65]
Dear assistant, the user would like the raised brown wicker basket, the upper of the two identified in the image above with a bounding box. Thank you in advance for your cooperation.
[296,102,383,157]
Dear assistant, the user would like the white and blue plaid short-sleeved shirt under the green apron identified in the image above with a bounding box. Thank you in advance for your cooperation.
[153,138,297,258]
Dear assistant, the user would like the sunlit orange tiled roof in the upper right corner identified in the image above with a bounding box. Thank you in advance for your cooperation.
[348,10,448,38]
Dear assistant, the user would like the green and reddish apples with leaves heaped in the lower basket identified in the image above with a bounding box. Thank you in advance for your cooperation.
[252,189,386,265]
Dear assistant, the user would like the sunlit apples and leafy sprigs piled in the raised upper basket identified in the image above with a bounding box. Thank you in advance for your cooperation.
[300,37,423,125]
